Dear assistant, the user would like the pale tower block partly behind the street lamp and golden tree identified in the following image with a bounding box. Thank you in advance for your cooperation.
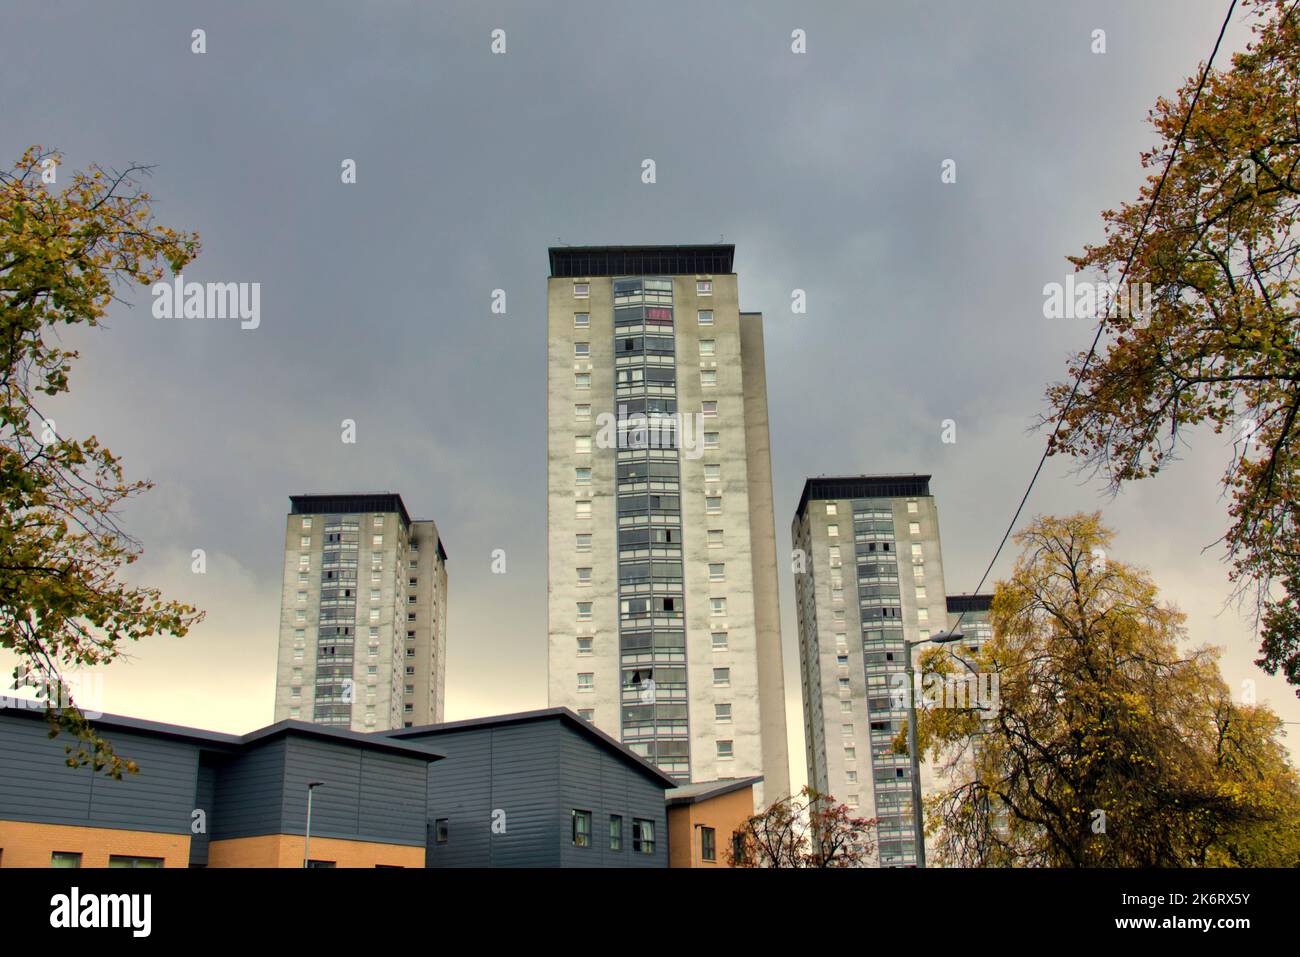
[792,475,965,866]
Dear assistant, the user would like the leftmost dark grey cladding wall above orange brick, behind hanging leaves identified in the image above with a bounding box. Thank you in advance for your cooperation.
[0,718,198,833]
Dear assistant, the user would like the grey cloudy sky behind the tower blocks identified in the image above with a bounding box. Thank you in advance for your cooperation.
[0,0,1300,781]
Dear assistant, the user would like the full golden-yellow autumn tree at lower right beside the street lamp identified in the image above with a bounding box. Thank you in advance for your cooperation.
[918,514,1300,867]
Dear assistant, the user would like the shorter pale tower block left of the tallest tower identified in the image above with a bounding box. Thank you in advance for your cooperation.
[276,492,447,731]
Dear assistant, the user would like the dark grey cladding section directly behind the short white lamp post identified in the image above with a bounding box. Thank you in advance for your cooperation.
[283,737,364,840]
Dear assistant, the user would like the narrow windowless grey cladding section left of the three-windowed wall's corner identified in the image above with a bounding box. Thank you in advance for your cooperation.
[484,720,560,867]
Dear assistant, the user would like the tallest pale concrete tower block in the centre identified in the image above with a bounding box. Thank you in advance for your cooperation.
[547,244,789,801]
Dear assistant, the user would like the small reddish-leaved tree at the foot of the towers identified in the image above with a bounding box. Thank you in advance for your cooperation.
[728,785,876,867]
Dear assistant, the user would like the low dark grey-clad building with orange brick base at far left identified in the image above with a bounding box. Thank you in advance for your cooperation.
[0,700,441,867]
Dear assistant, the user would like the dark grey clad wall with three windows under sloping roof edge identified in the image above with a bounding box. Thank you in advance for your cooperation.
[556,727,668,867]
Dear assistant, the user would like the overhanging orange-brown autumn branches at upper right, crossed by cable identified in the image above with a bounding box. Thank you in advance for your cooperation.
[1045,0,1300,694]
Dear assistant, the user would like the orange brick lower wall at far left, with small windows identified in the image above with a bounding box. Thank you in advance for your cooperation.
[0,820,190,867]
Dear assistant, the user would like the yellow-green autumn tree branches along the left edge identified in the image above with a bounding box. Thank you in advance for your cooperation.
[0,147,202,776]
